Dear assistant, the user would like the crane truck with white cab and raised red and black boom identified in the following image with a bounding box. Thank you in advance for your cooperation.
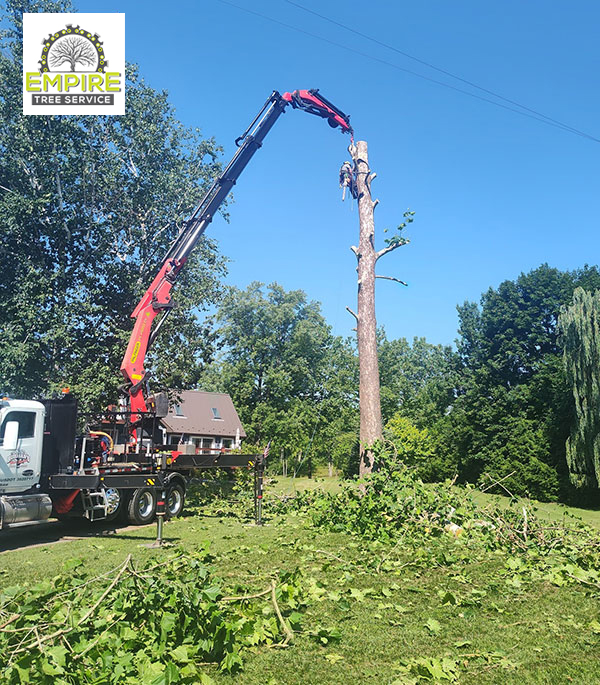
[0,89,353,529]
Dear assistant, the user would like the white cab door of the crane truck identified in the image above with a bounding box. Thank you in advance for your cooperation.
[0,408,44,494]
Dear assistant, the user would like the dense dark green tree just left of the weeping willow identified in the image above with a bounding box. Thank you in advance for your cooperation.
[438,264,600,499]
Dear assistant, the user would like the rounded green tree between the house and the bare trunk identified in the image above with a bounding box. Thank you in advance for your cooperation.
[202,282,358,466]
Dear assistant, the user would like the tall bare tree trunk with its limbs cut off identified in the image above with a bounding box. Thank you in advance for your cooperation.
[351,140,383,476]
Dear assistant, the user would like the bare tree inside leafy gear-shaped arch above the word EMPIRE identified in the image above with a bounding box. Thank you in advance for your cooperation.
[39,24,108,73]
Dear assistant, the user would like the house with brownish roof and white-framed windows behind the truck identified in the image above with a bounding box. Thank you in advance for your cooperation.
[160,390,246,454]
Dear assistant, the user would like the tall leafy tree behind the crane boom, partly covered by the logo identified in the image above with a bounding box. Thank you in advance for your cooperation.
[0,2,225,408]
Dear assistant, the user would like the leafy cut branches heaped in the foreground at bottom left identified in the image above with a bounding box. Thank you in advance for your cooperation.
[0,552,304,685]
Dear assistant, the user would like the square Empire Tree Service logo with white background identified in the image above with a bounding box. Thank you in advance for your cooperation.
[23,13,125,114]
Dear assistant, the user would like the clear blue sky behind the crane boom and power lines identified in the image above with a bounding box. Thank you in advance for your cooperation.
[74,0,600,343]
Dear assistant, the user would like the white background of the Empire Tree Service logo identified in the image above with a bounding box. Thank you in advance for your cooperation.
[23,12,125,114]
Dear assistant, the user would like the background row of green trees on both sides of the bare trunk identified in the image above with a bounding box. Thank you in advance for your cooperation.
[201,264,600,500]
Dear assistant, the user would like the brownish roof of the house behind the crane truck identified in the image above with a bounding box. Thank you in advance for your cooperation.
[161,390,246,438]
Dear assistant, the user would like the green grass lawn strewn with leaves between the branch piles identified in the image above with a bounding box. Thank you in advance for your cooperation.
[0,478,600,685]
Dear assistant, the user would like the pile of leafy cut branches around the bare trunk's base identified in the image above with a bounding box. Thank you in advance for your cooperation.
[271,448,600,590]
